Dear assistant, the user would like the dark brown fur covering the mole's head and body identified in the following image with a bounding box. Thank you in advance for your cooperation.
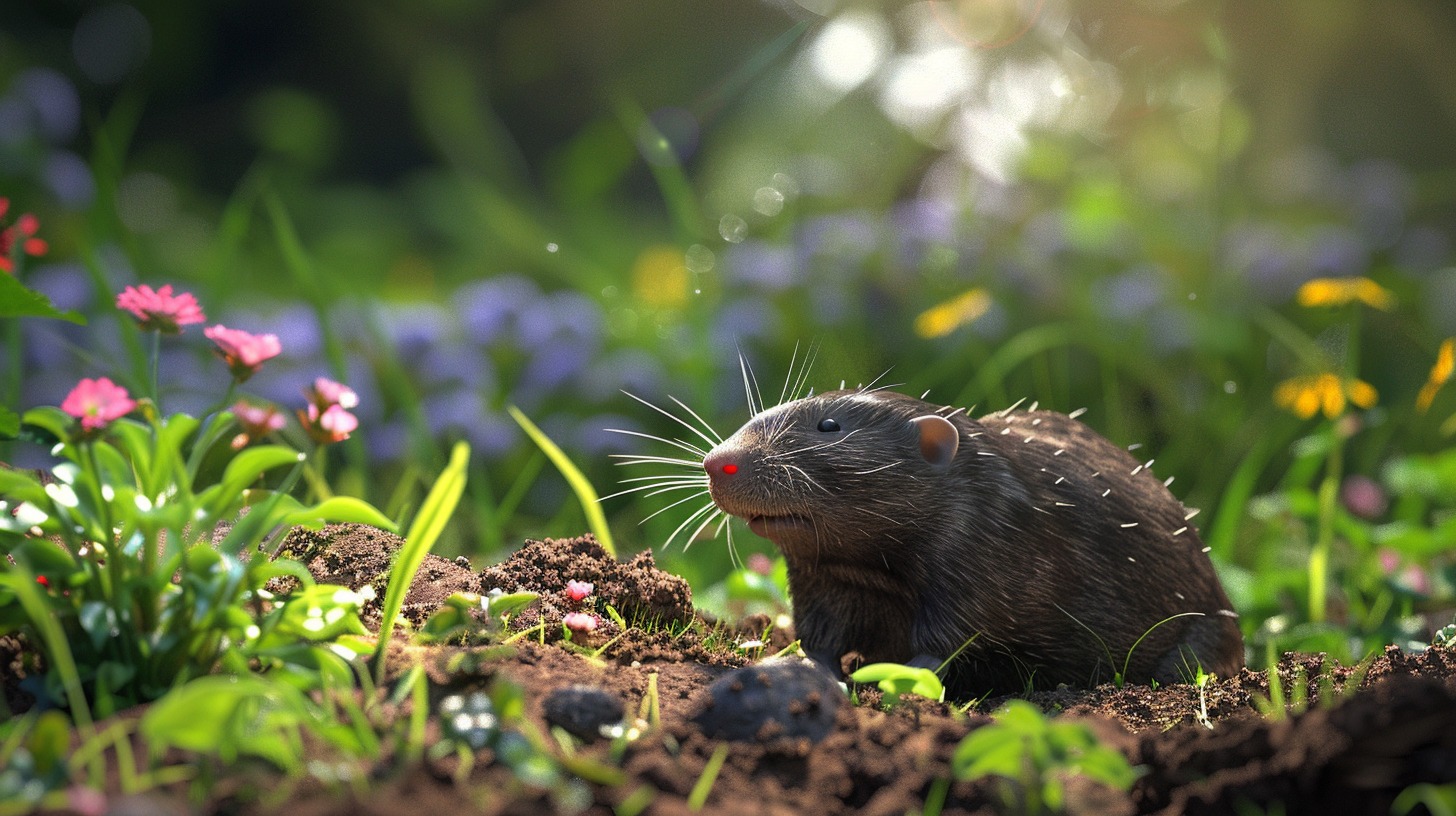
[705,391,1243,695]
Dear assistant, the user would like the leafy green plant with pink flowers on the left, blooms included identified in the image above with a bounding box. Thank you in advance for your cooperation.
[0,275,395,719]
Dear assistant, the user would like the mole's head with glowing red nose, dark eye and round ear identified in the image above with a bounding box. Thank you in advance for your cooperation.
[703,391,961,549]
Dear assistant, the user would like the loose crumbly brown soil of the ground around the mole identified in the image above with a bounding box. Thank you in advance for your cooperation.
[11,525,1456,816]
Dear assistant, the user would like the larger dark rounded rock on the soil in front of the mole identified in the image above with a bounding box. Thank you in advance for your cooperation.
[693,660,844,742]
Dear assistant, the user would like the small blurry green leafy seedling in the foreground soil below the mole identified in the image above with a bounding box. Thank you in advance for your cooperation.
[951,699,1137,813]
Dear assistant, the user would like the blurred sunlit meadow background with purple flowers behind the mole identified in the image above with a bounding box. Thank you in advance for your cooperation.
[0,0,1456,638]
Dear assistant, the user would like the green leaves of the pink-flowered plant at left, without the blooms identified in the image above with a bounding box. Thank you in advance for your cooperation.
[0,408,395,721]
